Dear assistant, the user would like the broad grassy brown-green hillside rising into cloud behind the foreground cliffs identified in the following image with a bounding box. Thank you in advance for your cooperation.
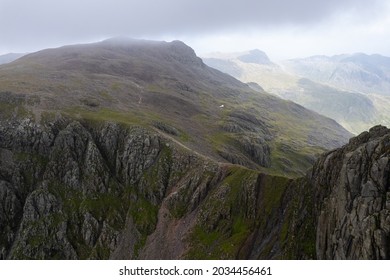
[0,38,350,176]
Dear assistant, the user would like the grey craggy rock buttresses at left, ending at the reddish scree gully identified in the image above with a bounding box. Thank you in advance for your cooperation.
[0,117,174,259]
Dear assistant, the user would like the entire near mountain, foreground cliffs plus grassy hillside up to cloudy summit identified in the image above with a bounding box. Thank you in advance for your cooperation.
[0,39,374,259]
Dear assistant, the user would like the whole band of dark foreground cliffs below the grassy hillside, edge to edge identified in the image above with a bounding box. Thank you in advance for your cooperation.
[0,118,390,259]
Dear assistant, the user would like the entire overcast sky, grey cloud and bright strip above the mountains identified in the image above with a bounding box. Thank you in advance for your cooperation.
[0,0,390,60]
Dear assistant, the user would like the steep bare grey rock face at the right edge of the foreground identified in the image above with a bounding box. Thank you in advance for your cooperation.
[311,126,390,259]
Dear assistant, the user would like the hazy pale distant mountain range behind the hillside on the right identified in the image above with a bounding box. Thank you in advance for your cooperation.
[204,50,390,133]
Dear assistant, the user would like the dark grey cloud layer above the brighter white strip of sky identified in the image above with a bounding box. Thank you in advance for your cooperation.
[0,0,385,52]
